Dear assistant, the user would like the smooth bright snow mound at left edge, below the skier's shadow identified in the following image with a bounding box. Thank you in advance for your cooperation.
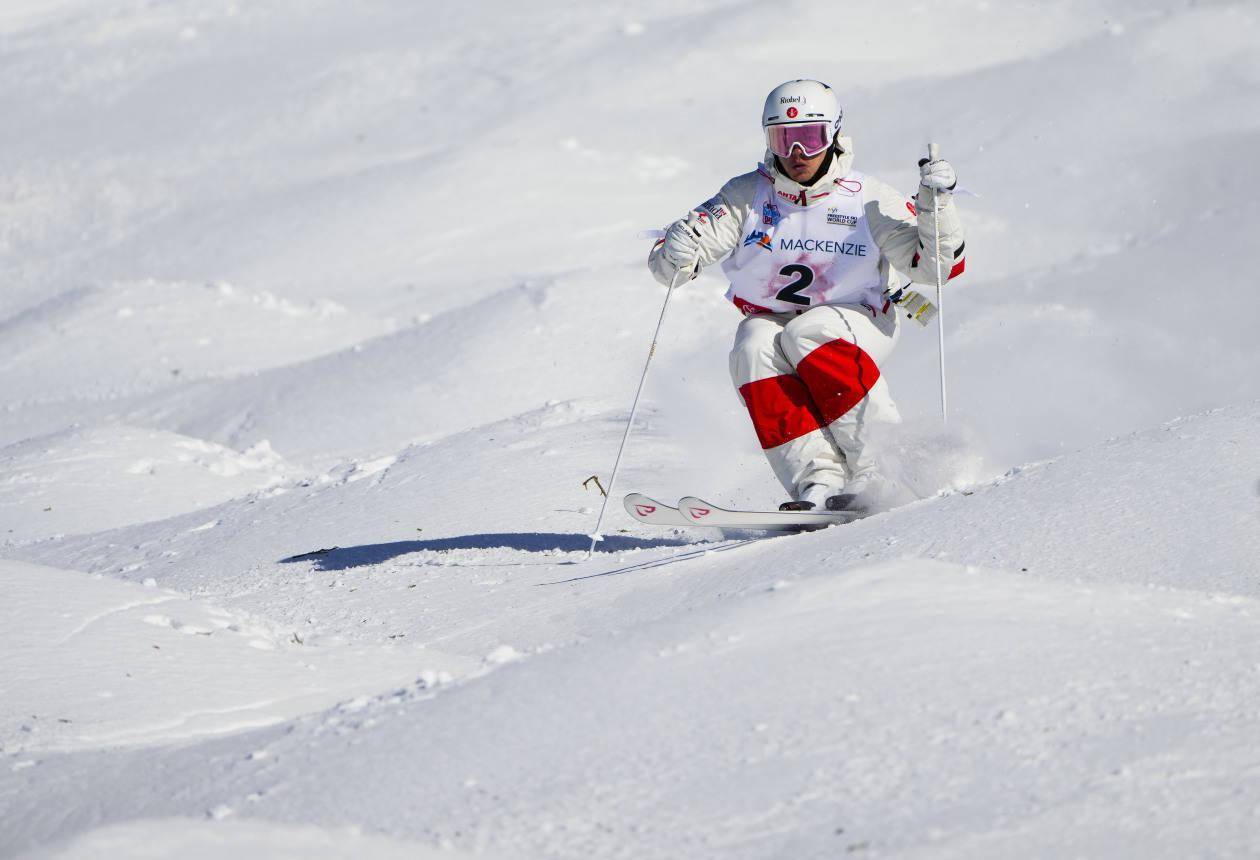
[0,562,464,761]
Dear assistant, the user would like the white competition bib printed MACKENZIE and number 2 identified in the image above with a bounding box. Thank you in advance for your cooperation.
[722,173,885,314]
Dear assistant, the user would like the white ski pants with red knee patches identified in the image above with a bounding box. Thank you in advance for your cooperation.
[731,305,901,499]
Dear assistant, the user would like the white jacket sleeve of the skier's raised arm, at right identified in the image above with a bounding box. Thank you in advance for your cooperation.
[866,176,966,285]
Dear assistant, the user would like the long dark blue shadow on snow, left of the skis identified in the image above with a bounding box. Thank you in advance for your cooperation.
[280,531,690,570]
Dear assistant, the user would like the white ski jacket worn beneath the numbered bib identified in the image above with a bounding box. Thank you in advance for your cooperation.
[648,137,965,312]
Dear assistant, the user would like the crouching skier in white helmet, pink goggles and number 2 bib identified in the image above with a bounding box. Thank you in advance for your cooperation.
[649,81,964,512]
